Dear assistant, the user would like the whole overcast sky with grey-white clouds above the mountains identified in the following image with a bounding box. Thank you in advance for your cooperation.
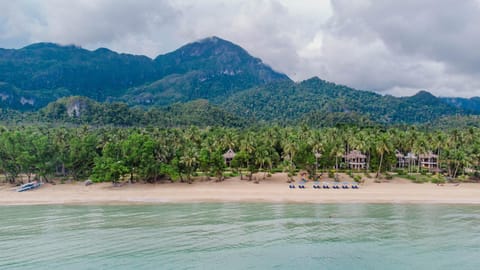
[0,0,480,97]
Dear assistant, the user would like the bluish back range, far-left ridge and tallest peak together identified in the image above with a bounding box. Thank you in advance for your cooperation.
[0,37,289,109]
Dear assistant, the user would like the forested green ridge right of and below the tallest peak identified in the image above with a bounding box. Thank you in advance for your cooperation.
[222,77,467,124]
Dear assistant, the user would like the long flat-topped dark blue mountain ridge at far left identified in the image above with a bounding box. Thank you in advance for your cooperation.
[0,43,157,106]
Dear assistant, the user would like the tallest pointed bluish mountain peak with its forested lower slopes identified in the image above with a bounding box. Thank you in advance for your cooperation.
[122,37,290,105]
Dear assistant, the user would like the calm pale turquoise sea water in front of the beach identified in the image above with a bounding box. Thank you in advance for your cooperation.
[0,203,480,270]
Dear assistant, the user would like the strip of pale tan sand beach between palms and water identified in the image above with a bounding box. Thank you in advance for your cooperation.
[0,173,480,205]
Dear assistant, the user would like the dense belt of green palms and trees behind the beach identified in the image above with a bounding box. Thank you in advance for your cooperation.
[0,125,480,186]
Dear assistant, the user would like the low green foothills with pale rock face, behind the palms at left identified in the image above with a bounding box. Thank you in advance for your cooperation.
[36,96,249,127]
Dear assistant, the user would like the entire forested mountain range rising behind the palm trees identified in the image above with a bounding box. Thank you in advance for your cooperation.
[0,37,480,127]
